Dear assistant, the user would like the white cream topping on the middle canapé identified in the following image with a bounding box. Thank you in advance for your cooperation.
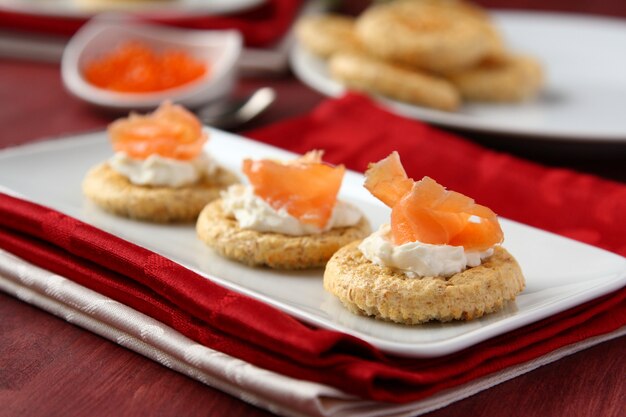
[222,185,361,236]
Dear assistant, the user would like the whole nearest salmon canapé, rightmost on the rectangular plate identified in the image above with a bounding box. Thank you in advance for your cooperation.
[324,152,525,324]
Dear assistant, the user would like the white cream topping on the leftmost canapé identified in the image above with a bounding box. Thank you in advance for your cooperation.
[109,152,216,188]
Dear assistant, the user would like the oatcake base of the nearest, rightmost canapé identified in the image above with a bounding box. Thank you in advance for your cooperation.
[324,241,525,324]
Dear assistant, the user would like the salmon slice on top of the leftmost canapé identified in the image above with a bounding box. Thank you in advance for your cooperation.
[108,101,208,160]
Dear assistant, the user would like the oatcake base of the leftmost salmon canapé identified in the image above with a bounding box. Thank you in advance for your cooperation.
[83,162,239,223]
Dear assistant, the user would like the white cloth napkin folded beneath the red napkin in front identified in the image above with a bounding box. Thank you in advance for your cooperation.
[0,249,626,417]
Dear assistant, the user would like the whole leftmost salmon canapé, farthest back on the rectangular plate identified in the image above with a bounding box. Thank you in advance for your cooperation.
[83,102,238,223]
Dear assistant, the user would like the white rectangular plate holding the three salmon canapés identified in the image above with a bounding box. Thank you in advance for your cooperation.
[0,130,626,357]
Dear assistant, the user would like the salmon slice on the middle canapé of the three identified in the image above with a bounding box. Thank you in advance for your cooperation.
[243,151,345,228]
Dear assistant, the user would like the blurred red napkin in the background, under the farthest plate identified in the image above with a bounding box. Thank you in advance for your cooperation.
[0,0,302,47]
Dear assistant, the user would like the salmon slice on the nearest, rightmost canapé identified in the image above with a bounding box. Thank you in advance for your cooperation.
[365,152,504,251]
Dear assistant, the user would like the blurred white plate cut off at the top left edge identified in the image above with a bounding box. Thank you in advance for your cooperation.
[0,0,265,18]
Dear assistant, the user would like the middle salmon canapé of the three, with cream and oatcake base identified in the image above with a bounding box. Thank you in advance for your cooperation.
[196,151,370,269]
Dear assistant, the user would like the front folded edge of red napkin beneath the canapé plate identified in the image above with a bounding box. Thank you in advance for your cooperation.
[0,190,626,403]
